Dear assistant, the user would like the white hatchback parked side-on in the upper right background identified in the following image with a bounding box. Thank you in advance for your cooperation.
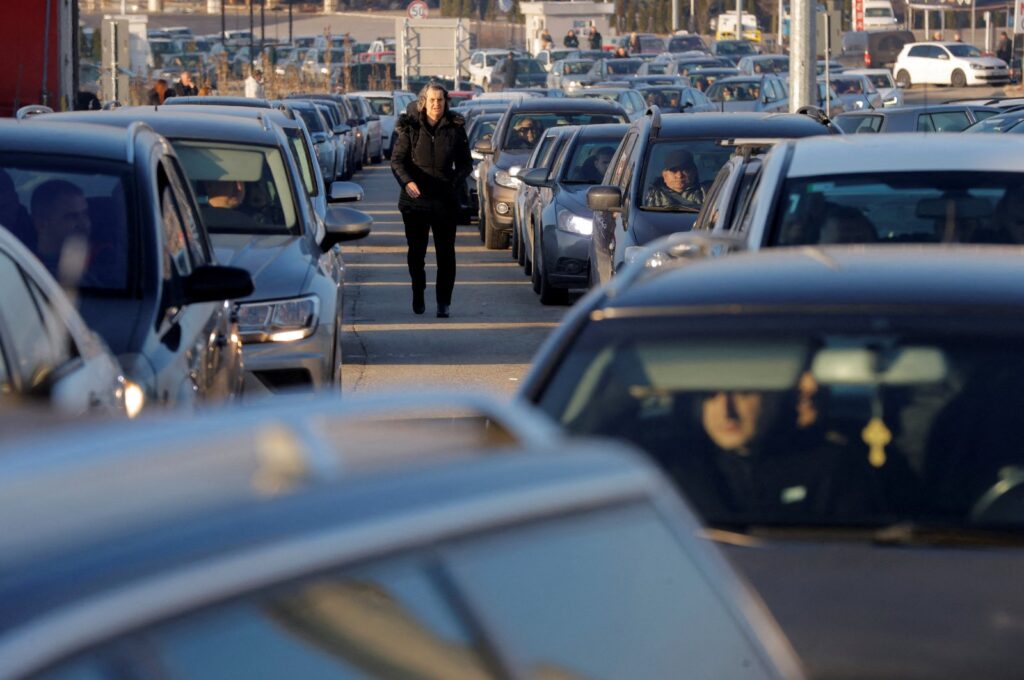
[893,42,1010,90]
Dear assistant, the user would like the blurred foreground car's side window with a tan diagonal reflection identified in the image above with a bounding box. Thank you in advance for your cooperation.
[44,558,498,680]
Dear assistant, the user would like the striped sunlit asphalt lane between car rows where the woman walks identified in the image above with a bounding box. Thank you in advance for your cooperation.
[342,162,567,394]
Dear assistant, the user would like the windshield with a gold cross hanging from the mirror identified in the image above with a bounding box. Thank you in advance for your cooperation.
[540,316,1024,528]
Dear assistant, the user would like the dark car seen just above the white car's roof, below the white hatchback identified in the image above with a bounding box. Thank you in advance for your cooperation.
[833,103,1000,134]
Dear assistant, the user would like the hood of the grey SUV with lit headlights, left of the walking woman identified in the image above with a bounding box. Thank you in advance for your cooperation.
[210,233,316,300]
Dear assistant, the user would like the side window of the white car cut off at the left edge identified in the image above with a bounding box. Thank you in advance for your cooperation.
[0,253,61,387]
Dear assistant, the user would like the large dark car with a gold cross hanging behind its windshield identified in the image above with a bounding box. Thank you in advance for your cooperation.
[520,246,1024,678]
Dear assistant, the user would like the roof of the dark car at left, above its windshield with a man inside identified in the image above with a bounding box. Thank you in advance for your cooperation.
[0,118,156,163]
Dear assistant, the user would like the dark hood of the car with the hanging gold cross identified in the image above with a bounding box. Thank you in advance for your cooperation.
[723,539,1024,678]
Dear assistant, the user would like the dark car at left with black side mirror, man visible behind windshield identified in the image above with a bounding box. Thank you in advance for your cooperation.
[0,118,253,407]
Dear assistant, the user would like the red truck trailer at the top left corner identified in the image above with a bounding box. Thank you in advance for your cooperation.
[0,0,78,117]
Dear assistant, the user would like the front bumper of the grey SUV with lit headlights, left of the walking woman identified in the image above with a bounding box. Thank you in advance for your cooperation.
[242,324,335,395]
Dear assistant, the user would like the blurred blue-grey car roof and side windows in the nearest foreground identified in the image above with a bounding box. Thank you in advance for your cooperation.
[0,394,802,680]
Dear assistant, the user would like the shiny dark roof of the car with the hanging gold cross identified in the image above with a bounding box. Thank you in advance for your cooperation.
[600,246,1024,317]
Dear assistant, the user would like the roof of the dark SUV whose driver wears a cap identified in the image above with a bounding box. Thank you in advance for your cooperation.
[657,113,828,138]
